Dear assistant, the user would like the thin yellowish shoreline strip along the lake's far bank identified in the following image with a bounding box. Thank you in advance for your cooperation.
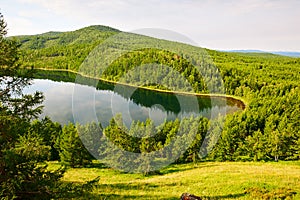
[30,68,248,110]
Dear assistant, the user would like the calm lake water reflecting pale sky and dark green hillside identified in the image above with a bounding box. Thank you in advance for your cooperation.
[25,72,243,127]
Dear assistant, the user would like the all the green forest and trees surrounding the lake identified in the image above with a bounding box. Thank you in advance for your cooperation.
[0,11,300,199]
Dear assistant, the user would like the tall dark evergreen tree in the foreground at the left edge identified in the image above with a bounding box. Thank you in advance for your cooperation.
[0,13,63,199]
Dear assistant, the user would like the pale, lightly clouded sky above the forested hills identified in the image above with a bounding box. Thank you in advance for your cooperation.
[0,0,300,51]
